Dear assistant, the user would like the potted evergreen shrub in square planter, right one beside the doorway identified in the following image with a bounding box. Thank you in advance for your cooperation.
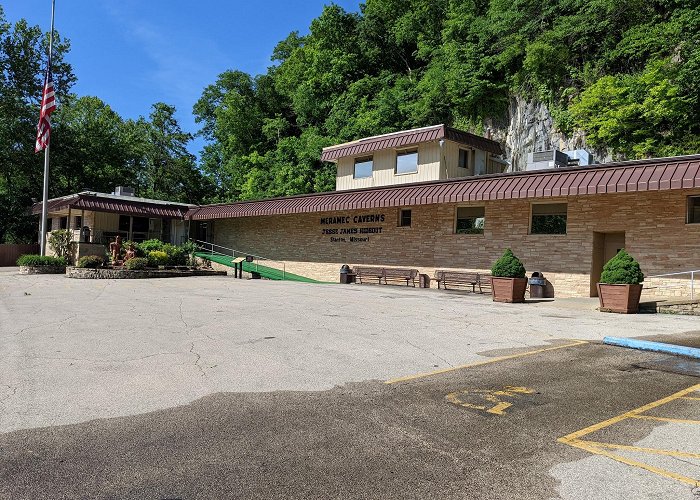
[597,248,644,314]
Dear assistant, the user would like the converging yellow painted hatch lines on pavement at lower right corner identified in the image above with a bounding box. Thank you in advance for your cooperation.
[557,384,700,487]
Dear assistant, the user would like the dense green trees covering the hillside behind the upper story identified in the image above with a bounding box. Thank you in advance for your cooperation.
[194,0,700,201]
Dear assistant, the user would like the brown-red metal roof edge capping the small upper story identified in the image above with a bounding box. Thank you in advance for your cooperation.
[321,125,503,161]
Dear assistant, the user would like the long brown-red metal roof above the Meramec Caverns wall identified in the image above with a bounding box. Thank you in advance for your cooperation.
[185,155,700,220]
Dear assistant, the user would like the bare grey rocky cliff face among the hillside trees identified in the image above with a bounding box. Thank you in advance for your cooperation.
[485,96,609,171]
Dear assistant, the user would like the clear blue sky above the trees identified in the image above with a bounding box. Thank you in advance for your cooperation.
[5,0,360,153]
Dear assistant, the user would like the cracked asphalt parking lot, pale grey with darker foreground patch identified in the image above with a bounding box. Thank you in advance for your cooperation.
[0,271,700,499]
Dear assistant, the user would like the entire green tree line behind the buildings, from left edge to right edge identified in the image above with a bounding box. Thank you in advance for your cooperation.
[0,0,700,242]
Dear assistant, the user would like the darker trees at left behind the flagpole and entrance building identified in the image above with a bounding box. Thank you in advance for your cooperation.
[0,5,208,243]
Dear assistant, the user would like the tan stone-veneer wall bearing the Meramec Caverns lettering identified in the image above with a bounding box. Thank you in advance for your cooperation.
[214,189,700,297]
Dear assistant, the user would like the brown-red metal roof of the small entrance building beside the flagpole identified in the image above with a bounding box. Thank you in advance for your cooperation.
[32,192,193,219]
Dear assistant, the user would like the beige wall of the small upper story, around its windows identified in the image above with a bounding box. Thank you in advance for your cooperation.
[335,141,502,191]
